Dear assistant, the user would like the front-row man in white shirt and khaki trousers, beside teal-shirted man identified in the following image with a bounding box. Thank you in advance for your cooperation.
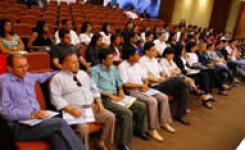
[119,48,175,141]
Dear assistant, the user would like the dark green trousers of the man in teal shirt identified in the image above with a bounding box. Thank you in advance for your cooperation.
[103,98,146,145]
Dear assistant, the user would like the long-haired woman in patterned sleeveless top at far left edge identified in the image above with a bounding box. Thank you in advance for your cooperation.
[0,19,24,54]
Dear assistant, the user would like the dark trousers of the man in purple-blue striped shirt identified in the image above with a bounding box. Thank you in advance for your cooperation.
[10,118,84,150]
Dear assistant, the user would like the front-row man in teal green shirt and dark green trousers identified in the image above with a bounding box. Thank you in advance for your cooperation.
[91,48,149,150]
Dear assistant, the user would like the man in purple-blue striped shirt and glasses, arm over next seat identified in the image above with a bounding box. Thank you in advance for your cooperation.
[0,54,84,150]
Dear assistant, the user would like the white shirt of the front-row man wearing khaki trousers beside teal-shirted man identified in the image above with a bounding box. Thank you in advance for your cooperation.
[118,60,146,84]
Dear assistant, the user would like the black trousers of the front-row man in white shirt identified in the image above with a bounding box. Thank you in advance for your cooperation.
[153,77,189,119]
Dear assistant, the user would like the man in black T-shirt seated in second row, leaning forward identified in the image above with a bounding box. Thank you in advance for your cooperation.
[50,28,90,71]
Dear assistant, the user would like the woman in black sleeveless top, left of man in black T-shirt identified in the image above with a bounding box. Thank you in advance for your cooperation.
[28,20,54,50]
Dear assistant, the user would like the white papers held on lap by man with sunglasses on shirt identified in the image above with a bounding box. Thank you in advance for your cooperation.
[63,108,95,125]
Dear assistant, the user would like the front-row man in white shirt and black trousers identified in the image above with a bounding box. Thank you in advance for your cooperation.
[139,42,190,125]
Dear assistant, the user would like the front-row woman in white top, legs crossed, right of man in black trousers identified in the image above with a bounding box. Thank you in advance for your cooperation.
[160,48,213,109]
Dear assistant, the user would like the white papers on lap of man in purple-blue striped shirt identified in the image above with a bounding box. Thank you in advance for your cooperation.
[19,110,59,127]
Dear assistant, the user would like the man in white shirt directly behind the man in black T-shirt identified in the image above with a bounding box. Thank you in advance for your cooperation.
[55,19,80,46]
